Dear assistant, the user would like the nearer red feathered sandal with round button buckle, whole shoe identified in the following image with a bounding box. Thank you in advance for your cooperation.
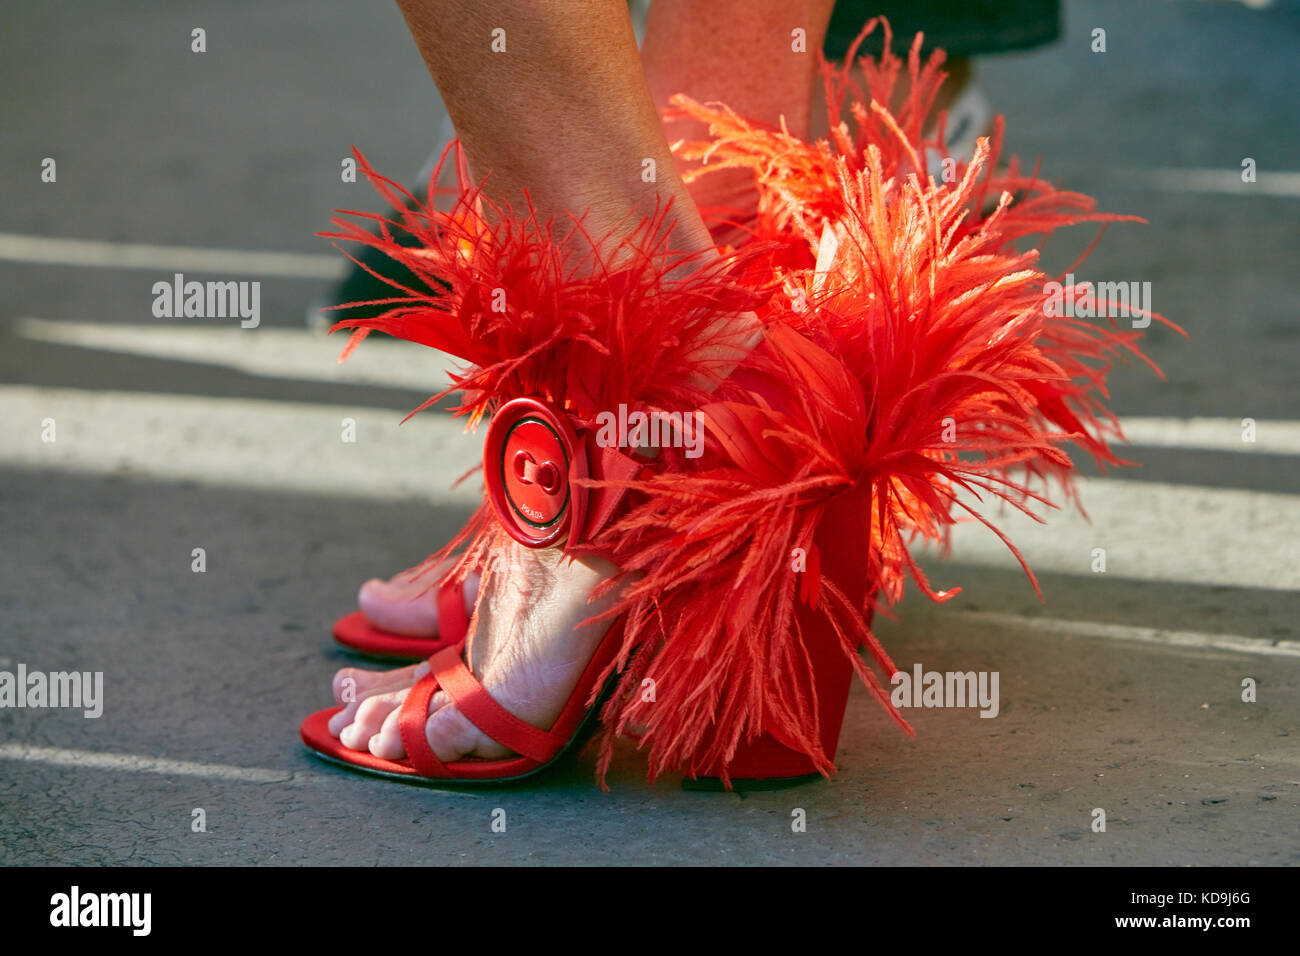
[303,140,893,786]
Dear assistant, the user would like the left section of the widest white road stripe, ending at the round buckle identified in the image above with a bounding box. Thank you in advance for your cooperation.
[0,385,481,505]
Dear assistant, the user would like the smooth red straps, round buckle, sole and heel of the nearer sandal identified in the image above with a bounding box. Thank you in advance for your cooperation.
[302,343,889,788]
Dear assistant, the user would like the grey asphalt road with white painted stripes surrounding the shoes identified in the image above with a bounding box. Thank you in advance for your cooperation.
[0,0,1300,865]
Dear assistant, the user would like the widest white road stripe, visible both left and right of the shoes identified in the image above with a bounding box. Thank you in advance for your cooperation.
[0,385,1300,589]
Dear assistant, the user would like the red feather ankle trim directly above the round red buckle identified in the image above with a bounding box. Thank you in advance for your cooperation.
[321,144,774,425]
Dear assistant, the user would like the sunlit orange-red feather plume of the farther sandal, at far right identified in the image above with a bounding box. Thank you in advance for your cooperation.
[673,18,1182,597]
